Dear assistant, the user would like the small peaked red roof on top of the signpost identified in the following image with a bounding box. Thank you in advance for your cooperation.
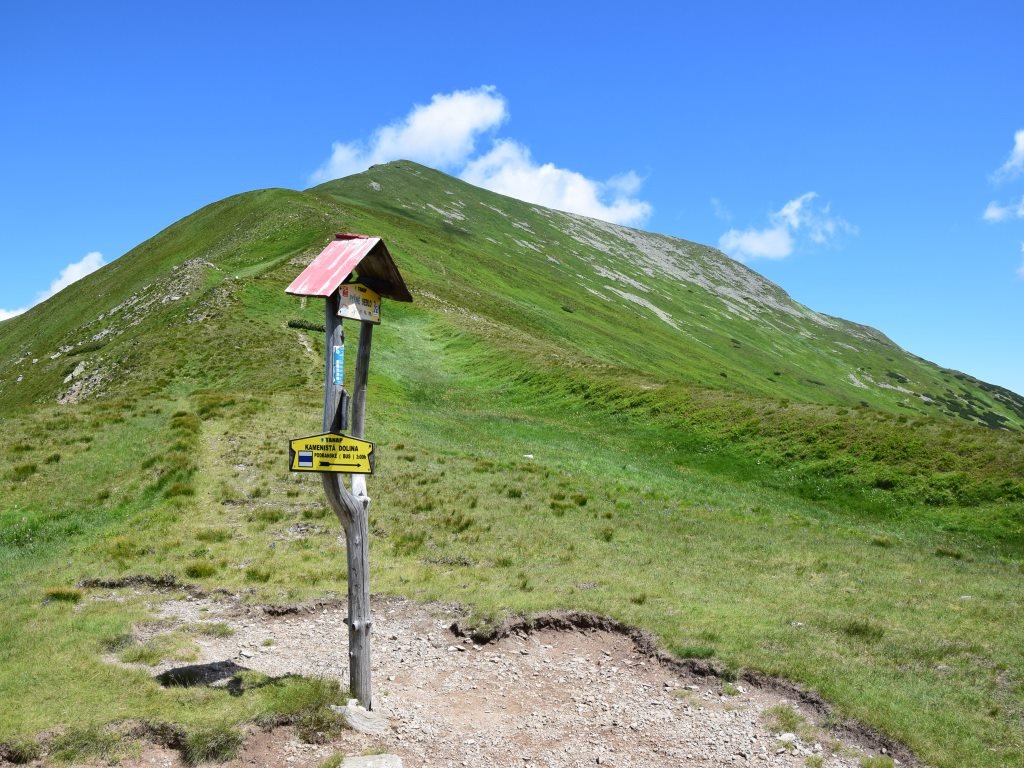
[285,232,413,301]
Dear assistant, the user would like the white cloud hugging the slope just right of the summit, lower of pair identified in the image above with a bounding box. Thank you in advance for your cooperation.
[461,139,651,224]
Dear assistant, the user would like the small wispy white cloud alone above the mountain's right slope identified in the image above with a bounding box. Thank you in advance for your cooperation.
[718,191,857,261]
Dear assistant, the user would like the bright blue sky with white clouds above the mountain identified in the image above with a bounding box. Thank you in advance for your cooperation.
[6,0,1024,393]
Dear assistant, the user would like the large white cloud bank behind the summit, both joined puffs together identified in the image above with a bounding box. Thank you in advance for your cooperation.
[309,85,651,224]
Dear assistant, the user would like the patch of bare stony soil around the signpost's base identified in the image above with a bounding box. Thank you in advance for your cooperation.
[36,594,916,768]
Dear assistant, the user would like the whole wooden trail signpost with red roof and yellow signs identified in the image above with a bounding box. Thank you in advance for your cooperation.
[286,233,413,710]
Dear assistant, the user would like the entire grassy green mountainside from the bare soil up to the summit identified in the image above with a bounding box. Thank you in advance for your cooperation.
[0,162,1024,766]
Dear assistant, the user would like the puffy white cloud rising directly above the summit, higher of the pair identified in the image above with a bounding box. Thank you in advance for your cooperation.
[309,85,508,184]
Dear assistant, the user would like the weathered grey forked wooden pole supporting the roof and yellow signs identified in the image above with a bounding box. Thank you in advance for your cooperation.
[321,293,373,710]
